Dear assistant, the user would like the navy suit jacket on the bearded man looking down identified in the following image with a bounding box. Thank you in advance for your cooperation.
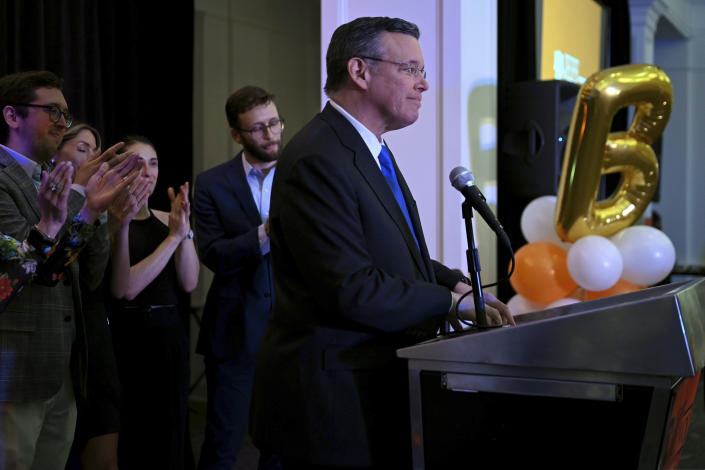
[193,153,274,361]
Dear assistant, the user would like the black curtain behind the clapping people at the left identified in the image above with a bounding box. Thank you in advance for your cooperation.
[0,0,194,209]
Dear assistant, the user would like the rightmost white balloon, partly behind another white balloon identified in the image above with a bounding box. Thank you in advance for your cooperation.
[612,225,676,286]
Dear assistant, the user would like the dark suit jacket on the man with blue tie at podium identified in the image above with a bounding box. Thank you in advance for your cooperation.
[253,104,460,468]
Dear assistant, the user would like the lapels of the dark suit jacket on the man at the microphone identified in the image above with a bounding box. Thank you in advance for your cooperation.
[321,104,428,278]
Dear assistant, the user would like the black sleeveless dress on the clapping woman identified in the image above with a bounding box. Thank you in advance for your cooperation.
[110,211,193,470]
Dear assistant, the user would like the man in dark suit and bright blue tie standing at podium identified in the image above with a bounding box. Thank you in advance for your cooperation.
[253,18,513,469]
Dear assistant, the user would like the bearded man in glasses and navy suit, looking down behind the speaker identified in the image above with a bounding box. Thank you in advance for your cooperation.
[193,86,284,470]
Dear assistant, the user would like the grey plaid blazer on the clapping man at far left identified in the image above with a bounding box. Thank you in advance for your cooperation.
[0,149,85,402]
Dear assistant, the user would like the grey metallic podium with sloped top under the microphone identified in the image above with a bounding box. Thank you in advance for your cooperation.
[397,280,705,470]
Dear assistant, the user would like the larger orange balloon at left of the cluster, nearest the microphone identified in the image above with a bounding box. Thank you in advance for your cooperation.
[509,242,578,304]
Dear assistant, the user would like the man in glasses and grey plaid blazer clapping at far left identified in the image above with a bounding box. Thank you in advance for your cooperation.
[0,71,140,469]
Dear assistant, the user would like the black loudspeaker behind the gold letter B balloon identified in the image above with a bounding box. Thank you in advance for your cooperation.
[497,80,580,301]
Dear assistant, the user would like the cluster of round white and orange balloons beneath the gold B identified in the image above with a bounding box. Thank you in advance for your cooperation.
[508,196,676,315]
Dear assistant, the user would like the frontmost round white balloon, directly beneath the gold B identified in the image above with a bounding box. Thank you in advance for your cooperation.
[567,235,622,291]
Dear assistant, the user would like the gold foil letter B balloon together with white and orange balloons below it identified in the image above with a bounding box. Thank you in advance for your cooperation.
[508,64,676,314]
